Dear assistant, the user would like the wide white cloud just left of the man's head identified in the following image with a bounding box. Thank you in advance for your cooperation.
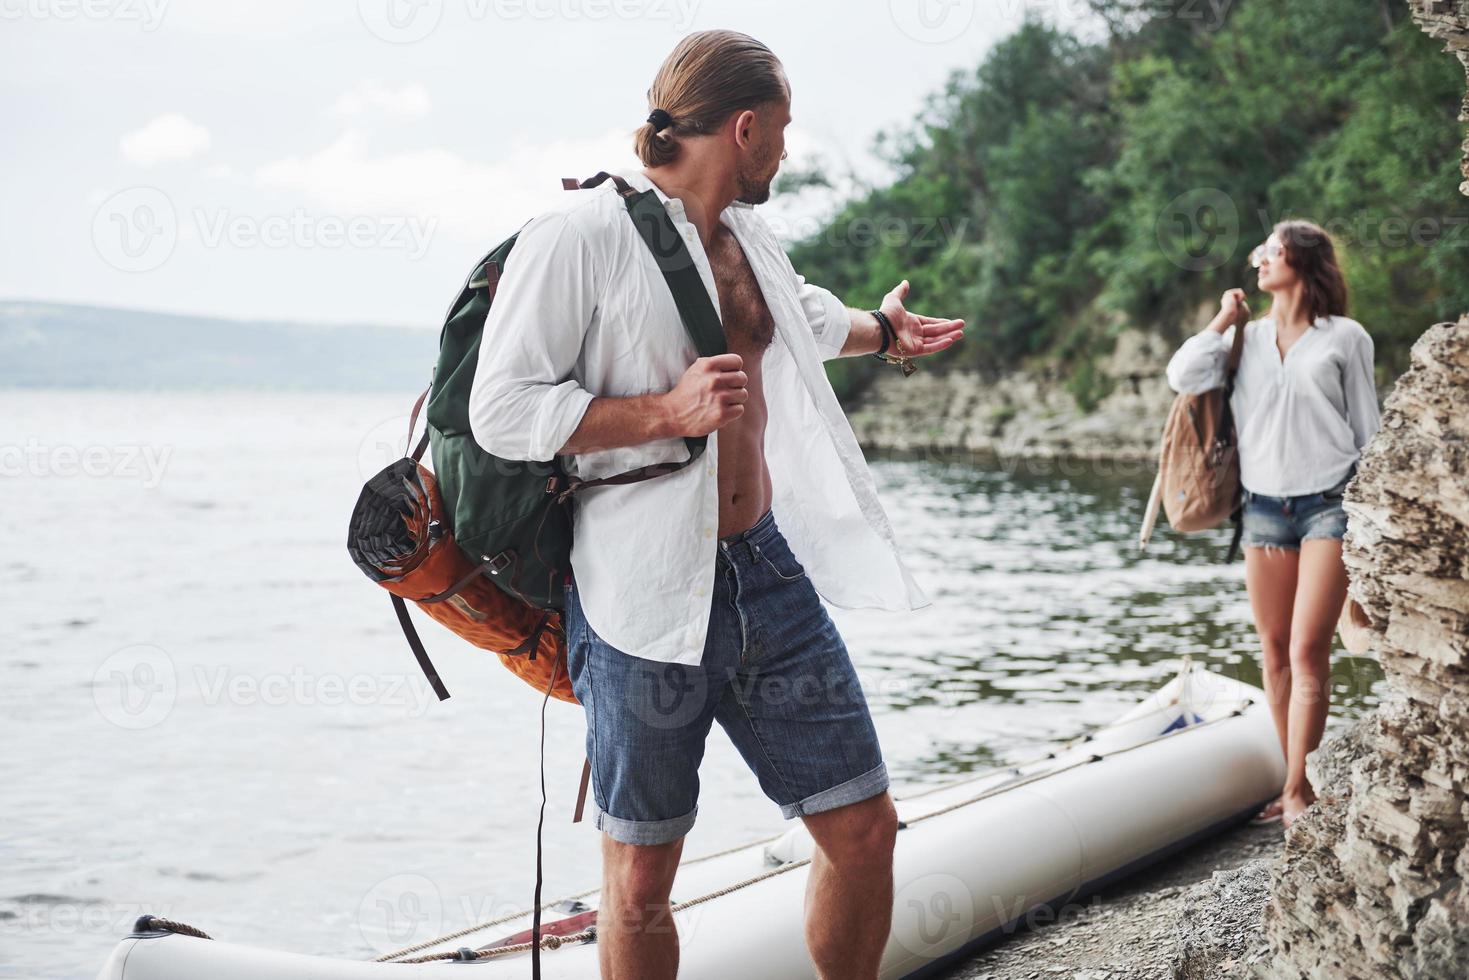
[256,129,638,244]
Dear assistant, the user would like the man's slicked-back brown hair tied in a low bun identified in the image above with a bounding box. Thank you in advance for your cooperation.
[633,31,790,166]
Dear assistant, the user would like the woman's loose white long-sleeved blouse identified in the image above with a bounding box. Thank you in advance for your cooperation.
[1168,316,1379,497]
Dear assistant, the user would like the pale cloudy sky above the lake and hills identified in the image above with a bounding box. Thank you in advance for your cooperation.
[0,0,1104,329]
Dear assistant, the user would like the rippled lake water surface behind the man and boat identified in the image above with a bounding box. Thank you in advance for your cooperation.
[0,391,1379,977]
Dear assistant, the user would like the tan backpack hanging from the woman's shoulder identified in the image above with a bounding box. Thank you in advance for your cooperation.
[1137,313,1247,561]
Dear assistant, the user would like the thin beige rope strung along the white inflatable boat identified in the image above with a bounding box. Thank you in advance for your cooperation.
[378,698,1255,962]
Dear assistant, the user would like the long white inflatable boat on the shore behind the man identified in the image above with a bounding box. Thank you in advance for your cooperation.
[97,660,1285,980]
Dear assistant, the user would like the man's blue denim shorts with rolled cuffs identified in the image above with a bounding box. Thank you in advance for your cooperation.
[564,511,887,845]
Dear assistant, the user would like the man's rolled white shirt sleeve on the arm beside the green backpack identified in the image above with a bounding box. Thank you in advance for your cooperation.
[469,212,598,461]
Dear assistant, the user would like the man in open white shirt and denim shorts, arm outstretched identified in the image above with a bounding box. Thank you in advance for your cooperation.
[469,31,964,980]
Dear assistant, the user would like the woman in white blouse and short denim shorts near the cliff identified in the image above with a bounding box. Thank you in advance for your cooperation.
[1168,220,1378,827]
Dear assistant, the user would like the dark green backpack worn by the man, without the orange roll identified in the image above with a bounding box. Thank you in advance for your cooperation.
[420,172,727,610]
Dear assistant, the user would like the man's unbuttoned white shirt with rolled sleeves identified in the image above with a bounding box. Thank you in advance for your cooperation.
[469,170,930,664]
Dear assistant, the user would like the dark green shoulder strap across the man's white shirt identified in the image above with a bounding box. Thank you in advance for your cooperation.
[558,170,729,500]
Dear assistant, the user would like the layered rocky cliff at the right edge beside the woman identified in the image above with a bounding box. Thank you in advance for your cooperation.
[1257,7,1469,980]
